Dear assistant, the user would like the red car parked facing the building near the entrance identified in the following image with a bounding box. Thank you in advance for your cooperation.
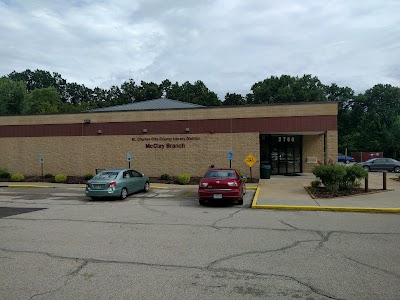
[198,169,246,205]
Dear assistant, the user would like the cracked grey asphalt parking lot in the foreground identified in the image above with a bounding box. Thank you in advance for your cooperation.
[0,188,400,300]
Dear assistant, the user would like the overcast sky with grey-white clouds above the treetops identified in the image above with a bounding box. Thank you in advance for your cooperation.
[0,0,400,99]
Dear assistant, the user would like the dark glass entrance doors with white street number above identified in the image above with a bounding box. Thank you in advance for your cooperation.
[260,134,302,175]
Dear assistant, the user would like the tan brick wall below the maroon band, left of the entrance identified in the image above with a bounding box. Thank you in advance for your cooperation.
[0,133,259,178]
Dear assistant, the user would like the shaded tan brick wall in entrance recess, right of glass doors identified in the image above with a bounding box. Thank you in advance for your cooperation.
[302,134,324,173]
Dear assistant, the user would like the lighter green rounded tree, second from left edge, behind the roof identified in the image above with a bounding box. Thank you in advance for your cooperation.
[22,87,63,115]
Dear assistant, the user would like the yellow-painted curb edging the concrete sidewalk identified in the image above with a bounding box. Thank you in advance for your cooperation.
[251,187,400,213]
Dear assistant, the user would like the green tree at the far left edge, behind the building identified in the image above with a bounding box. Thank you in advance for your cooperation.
[0,77,26,115]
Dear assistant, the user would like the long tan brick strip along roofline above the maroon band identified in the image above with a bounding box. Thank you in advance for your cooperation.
[0,102,337,126]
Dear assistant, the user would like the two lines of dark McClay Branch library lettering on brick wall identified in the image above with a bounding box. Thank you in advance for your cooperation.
[132,136,200,149]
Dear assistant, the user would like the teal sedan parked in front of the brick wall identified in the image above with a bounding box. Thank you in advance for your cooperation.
[85,169,150,200]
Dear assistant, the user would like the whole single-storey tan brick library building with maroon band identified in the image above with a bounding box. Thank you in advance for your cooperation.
[0,99,338,178]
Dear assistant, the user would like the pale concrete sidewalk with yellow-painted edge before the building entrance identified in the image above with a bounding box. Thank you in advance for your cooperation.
[252,172,400,213]
